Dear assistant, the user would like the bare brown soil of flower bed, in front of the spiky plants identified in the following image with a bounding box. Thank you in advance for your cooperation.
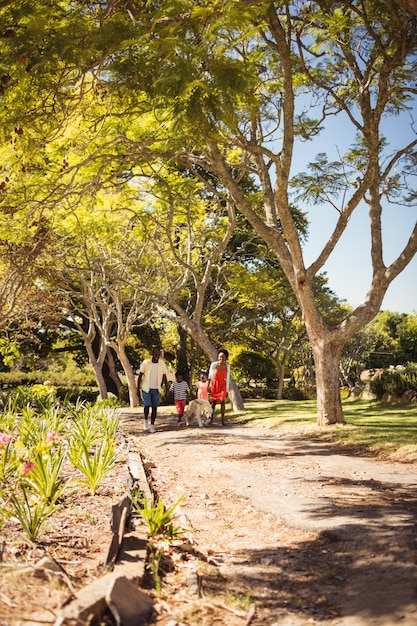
[0,465,126,626]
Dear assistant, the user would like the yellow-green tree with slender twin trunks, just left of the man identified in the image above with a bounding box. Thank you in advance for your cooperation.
[50,193,156,407]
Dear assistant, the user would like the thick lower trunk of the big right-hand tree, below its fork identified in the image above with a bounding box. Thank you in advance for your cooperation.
[312,341,345,426]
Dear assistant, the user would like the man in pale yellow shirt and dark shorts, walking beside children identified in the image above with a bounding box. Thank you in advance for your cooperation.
[138,348,168,433]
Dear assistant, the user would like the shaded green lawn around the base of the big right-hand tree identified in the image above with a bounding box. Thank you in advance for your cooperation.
[232,399,417,462]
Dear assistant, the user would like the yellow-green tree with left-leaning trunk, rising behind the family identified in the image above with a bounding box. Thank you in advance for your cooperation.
[126,171,243,411]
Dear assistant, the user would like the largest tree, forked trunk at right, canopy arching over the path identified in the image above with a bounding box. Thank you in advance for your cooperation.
[2,0,417,425]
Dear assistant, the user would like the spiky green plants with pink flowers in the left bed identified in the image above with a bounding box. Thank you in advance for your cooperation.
[0,392,121,541]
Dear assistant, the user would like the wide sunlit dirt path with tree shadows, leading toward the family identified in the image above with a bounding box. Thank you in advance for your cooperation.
[123,407,417,626]
